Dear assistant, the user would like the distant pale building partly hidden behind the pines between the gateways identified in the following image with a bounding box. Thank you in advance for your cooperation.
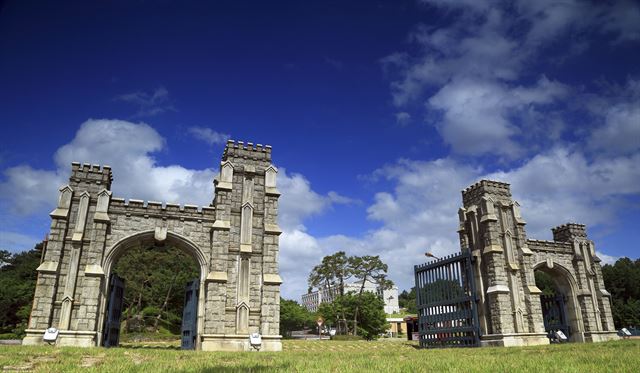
[302,281,400,314]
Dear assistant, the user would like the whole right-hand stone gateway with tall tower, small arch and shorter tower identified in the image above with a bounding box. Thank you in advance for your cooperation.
[458,180,618,346]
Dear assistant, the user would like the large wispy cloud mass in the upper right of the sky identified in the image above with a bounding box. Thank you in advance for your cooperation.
[381,0,640,160]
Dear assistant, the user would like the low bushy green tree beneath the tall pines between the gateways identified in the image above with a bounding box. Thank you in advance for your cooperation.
[318,292,388,339]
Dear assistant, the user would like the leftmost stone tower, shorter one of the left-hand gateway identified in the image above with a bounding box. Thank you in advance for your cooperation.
[23,162,112,346]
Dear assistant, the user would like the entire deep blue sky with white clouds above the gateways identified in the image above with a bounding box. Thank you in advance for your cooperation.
[0,0,640,298]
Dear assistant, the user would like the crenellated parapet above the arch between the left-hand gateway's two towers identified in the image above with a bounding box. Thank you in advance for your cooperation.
[109,197,216,219]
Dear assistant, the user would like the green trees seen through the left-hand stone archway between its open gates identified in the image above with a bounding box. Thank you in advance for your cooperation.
[113,246,199,334]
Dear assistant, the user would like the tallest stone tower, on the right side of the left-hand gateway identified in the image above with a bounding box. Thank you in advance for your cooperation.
[202,140,282,351]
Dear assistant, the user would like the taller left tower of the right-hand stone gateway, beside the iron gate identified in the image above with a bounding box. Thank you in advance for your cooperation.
[462,180,548,346]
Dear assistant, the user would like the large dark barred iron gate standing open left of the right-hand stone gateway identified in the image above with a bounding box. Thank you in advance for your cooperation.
[414,253,480,348]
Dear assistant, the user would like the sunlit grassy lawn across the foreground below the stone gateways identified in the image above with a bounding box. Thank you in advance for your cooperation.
[0,340,640,373]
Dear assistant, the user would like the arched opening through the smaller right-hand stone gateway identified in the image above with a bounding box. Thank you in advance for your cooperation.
[534,262,584,342]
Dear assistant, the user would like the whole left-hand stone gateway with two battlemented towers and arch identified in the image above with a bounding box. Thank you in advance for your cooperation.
[23,140,282,351]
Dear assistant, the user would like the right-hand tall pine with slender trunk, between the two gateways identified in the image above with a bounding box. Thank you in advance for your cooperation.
[349,255,393,334]
